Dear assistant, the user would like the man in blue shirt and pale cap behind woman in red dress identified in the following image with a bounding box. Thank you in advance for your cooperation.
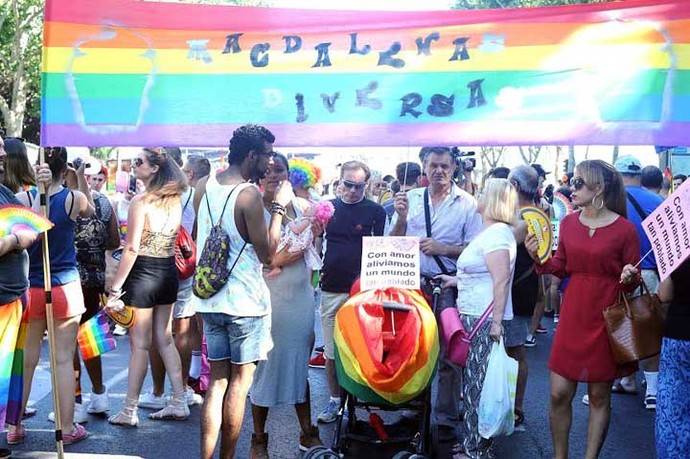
[614,156,663,410]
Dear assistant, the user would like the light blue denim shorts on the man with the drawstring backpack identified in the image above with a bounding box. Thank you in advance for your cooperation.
[201,312,273,365]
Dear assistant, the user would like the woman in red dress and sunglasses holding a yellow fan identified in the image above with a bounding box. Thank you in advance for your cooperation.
[525,160,640,459]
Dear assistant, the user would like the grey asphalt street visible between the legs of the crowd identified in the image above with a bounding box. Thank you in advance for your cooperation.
[0,312,655,459]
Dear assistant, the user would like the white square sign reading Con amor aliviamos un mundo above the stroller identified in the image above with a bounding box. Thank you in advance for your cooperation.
[360,237,420,290]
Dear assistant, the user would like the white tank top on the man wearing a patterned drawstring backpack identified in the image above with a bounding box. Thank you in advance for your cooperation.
[196,173,271,317]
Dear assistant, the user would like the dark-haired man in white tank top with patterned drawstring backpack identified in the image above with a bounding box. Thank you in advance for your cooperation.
[193,125,294,459]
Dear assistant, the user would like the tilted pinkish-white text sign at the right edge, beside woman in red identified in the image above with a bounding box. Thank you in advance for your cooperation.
[642,180,690,281]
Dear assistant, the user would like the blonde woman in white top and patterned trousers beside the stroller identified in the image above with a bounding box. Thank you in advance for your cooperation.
[439,179,518,458]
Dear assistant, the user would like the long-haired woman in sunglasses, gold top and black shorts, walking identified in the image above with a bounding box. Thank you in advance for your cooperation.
[108,148,189,427]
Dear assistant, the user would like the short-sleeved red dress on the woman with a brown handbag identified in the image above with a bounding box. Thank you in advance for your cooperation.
[537,213,640,382]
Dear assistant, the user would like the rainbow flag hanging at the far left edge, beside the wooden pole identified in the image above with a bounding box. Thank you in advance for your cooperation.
[0,300,27,426]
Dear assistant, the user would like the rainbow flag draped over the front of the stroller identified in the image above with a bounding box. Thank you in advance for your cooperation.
[334,288,439,405]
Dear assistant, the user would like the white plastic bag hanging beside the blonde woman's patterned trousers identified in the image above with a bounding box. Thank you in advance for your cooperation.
[478,338,518,438]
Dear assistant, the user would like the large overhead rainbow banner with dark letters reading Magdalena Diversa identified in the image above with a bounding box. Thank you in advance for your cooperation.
[41,0,690,146]
